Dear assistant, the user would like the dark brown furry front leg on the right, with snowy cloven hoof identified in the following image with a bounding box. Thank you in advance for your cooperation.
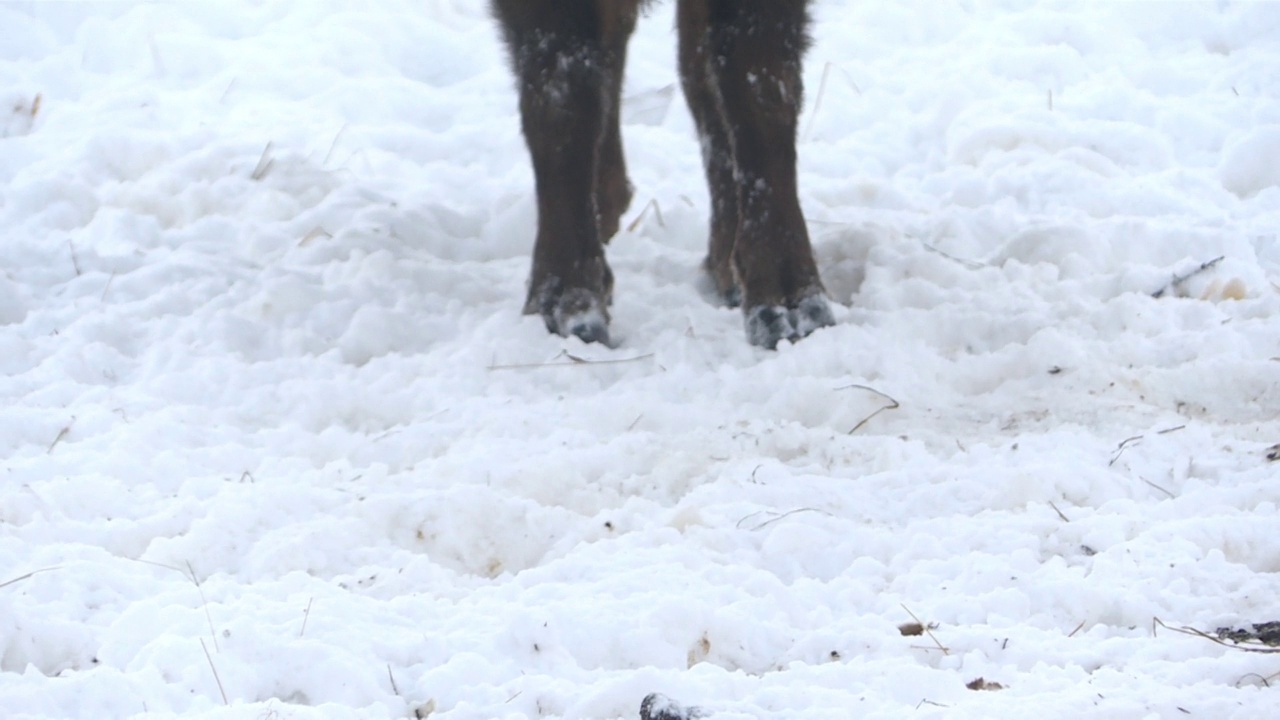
[680,0,833,348]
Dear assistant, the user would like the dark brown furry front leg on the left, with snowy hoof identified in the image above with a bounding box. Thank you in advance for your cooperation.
[493,0,636,342]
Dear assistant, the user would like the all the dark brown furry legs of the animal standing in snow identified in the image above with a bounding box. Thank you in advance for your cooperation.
[493,0,832,347]
